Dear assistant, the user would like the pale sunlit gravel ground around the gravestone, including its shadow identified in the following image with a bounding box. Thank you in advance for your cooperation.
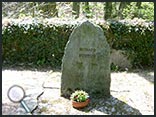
[2,69,154,115]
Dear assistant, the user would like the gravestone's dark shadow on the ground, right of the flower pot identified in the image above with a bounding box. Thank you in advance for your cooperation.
[78,96,142,115]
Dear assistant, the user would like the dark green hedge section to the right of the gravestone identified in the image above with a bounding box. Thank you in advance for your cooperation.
[107,20,154,67]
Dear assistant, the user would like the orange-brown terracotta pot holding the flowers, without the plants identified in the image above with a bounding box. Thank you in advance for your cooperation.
[72,99,90,108]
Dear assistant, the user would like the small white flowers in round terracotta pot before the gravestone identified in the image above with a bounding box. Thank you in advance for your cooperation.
[70,90,90,108]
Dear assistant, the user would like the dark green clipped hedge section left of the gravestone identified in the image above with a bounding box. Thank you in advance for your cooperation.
[2,19,75,67]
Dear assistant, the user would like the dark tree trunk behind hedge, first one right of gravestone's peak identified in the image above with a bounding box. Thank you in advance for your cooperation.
[104,2,112,20]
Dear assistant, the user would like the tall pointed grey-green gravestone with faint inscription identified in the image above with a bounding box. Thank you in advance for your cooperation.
[61,21,111,97]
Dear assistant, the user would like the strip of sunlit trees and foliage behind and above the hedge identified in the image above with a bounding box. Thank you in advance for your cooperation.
[2,2,154,21]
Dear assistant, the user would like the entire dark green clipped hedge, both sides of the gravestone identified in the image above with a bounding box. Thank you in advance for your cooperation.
[2,20,154,67]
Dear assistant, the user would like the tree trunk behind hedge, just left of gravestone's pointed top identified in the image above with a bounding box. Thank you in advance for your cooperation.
[72,2,80,19]
